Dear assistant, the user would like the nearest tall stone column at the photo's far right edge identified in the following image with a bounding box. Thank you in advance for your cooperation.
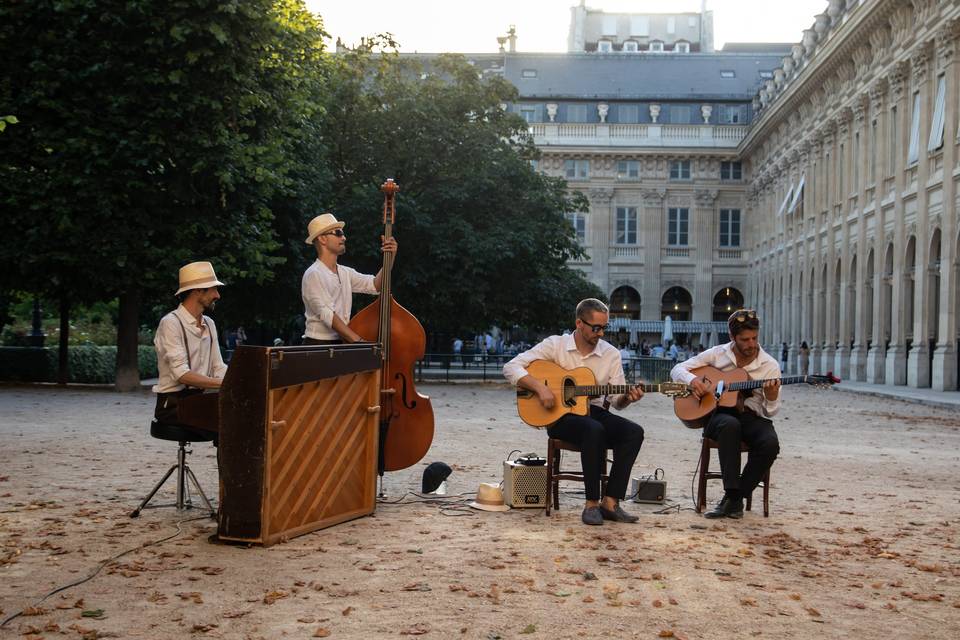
[930,21,960,391]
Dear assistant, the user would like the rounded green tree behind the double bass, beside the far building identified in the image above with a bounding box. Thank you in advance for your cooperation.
[322,50,601,340]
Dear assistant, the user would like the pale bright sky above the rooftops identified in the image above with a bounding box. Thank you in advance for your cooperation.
[306,0,827,53]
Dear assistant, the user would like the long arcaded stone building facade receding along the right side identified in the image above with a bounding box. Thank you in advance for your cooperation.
[738,0,960,390]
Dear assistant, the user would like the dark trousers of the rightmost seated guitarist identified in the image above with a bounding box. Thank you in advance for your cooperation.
[703,410,780,497]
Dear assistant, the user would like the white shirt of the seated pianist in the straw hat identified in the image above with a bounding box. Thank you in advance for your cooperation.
[153,305,227,393]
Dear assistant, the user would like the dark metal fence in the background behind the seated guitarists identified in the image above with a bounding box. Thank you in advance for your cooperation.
[416,353,675,383]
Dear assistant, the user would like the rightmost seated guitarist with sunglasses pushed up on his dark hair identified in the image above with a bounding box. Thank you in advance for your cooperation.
[670,309,780,518]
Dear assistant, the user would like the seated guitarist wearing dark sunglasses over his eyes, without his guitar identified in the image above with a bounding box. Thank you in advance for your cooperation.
[503,298,643,525]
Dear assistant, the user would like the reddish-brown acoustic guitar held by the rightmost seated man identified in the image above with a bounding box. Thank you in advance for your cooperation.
[673,367,840,429]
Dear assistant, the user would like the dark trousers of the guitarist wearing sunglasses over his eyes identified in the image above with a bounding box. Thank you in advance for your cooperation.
[547,405,643,500]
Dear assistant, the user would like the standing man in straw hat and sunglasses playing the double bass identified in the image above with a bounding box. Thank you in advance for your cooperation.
[300,213,397,344]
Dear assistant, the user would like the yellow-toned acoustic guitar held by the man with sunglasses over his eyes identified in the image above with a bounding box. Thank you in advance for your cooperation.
[517,360,692,429]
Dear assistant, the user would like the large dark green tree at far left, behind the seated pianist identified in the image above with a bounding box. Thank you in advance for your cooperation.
[0,0,323,388]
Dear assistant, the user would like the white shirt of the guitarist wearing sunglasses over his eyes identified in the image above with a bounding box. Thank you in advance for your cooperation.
[503,334,627,408]
